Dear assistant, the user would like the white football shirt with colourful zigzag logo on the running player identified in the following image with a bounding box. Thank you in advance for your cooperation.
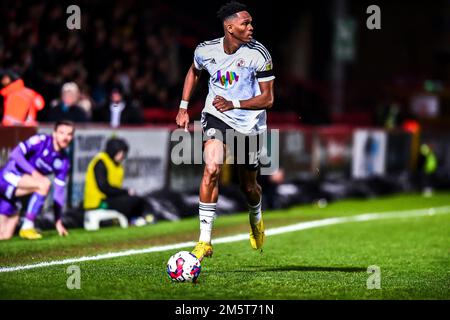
[194,37,275,134]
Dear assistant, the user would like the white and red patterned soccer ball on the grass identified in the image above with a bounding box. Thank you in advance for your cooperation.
[167,251,201,282]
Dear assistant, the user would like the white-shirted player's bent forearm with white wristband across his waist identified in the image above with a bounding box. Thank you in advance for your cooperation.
[213,80,274,112]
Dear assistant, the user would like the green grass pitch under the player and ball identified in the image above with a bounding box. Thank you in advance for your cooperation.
[0,192,450,300]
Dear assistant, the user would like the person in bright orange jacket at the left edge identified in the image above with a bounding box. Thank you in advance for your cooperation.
[0,70,45,126]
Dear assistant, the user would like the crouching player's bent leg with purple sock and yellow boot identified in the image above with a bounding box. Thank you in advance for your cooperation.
[15,174,50,240]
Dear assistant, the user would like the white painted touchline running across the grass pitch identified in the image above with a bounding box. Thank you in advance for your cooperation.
[0,206,450,273]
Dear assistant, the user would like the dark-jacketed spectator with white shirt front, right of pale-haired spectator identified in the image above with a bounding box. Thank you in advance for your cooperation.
[95,86,143,128]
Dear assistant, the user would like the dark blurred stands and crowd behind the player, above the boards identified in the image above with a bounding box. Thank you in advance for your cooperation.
[0,0,450,126]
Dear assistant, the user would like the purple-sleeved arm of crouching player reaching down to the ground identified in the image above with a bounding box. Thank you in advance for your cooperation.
[53,161,70,236]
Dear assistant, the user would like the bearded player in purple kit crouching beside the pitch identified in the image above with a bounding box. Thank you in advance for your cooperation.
[0,121,75,240]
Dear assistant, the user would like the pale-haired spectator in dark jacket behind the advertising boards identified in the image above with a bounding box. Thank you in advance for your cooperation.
[46,82,89,122]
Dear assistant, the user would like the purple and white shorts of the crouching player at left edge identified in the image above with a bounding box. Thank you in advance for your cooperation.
[0,169,21,216]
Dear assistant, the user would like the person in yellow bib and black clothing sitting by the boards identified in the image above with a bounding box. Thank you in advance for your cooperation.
[83,138,153,225]
